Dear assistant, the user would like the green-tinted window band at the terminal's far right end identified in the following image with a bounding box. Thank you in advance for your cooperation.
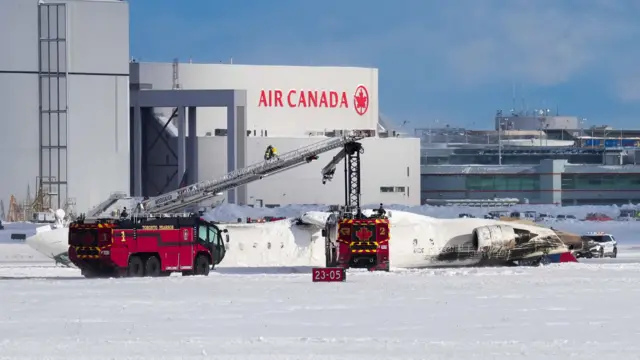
[562,173,640,191]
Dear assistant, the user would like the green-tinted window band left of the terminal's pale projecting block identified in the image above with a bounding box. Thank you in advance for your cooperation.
[466,174,540,191]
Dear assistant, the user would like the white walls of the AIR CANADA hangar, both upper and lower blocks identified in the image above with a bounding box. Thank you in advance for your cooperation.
[131,62,420,205]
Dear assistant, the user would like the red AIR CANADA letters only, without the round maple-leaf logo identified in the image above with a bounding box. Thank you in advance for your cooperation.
[258,89,349,109]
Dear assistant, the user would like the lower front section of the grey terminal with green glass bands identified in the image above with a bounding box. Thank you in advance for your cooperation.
[421,159,640,205]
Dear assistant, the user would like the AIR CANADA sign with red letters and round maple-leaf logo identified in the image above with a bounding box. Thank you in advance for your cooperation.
[258,85,369,116]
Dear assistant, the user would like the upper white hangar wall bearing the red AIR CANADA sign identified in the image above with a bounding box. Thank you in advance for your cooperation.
[132,62,378,137]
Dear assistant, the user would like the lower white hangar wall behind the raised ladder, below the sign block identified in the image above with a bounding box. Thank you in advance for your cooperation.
[198,136,420,206]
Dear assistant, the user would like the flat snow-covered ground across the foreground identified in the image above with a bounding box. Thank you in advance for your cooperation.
[0,260,640,360]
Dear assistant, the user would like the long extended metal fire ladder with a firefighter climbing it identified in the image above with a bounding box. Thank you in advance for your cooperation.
[138,131,368,214]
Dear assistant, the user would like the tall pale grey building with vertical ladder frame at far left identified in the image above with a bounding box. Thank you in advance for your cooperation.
[0,0,129,211]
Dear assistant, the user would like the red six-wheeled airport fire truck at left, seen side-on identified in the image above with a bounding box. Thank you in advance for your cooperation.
[69,215,229,277]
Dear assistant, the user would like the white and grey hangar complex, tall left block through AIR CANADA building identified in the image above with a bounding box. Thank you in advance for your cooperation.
[0,0,420,212]
